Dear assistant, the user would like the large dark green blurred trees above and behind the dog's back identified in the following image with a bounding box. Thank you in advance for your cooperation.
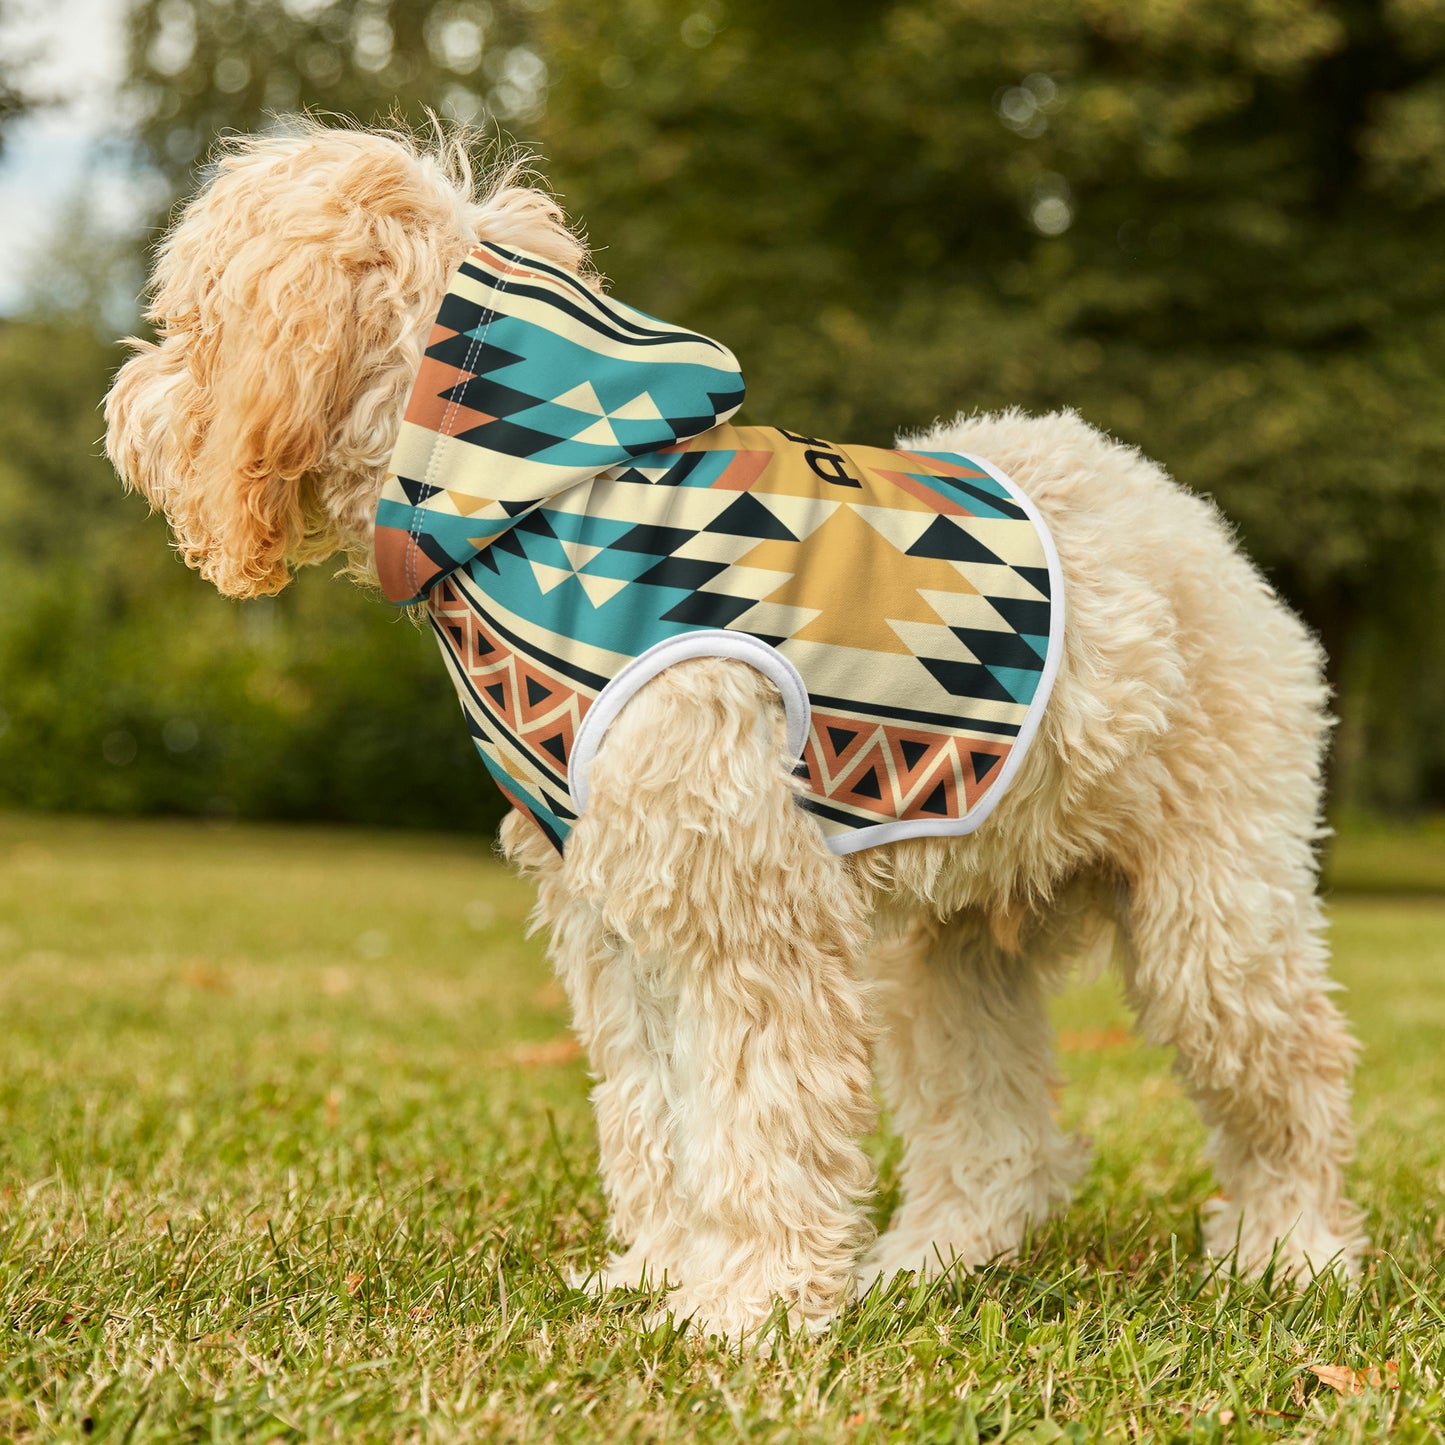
[536,0,1445,802]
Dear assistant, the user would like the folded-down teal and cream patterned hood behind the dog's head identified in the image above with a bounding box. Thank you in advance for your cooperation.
[376,243,744,605]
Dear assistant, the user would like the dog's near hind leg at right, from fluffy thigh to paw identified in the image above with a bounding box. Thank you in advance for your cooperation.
[1091,575,1363,1274]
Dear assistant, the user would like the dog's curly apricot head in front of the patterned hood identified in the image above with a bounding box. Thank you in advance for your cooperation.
[105,121,587,597]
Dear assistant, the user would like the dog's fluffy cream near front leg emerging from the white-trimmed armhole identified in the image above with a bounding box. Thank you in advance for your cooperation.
[565,659,874,1340]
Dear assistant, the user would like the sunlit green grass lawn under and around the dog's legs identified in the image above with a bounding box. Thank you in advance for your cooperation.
[0,816,1445,1445]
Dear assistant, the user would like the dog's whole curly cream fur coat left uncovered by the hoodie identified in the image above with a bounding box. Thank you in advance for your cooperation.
[107,124,1363,1338]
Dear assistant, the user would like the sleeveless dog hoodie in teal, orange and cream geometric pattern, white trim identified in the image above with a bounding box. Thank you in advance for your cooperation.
[376,243,1064,853]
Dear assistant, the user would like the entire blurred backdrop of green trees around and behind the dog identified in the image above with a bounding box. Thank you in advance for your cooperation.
[0,0,1445,827]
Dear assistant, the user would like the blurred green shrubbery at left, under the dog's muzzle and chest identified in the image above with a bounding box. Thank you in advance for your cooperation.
[0,315,503,829]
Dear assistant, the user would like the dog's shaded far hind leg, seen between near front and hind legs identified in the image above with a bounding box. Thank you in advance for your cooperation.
[860,912,1087,1286]
